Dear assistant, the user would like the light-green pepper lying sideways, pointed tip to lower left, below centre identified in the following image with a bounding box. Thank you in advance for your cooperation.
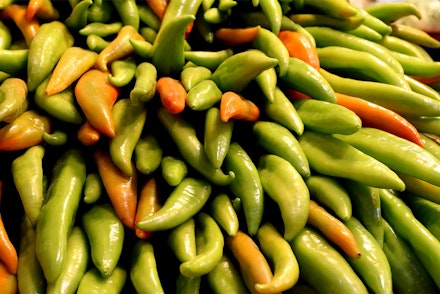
[136,177,212,231]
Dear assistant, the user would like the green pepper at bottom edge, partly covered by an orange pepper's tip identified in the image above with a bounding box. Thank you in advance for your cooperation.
[344,217,393,293]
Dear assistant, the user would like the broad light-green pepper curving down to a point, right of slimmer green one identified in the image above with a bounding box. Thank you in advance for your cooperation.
[258,154,310,242]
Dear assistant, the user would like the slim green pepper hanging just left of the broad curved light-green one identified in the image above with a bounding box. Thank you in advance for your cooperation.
[224,142,264,235]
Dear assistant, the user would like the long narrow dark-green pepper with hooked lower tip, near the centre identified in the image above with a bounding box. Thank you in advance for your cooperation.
[157,108,235,186]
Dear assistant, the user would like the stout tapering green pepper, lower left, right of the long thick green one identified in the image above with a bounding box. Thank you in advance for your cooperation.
[81,203,125,278]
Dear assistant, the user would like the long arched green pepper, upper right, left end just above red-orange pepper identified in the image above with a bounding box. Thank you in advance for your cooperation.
[305,26,403,74]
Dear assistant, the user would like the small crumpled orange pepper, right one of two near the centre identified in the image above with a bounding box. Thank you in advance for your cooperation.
[220,91,260,122]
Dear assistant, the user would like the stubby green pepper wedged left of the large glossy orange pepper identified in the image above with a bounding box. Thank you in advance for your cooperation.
[33,75,83,124]
